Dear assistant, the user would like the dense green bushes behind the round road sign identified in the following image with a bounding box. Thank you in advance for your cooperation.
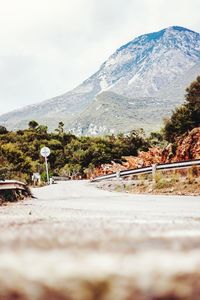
[0,121,149,182]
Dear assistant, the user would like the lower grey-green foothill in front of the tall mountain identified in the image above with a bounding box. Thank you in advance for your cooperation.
[70,91,177,135]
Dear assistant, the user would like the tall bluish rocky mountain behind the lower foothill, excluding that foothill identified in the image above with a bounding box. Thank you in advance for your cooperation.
[0,26,200,134]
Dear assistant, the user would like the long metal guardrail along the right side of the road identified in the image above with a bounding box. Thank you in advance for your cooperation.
[91,159,200,182]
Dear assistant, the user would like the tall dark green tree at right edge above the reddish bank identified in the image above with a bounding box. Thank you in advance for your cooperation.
[164,76,200,142]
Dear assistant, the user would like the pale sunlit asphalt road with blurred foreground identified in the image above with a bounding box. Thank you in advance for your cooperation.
[0,181,200,300]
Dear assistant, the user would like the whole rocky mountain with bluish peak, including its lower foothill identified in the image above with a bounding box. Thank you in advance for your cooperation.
[0,26,200,134]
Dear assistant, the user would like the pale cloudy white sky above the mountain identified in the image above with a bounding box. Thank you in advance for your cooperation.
[0,0,200,114]
